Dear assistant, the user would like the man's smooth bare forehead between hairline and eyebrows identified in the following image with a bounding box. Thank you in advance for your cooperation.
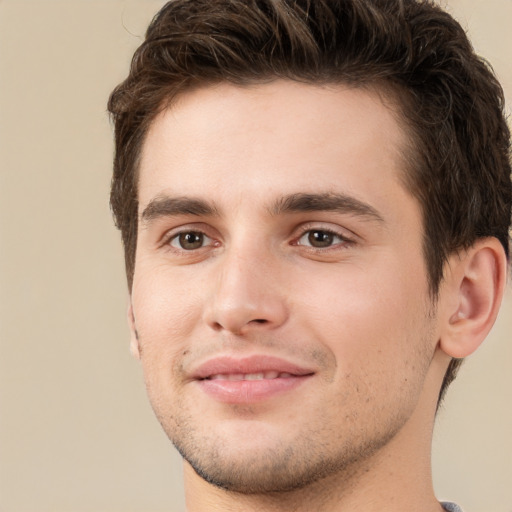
[139,81,407,212]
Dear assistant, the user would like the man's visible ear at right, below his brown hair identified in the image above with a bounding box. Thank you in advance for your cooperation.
[440,238,507,359]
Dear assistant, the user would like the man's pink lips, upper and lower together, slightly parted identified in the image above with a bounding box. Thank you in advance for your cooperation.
[192,355,315,404]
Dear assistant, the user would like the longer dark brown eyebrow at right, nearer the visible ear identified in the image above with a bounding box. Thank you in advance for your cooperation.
[270,192,384,223]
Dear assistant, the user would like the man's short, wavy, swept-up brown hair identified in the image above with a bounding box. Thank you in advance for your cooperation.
[108,0,512,400]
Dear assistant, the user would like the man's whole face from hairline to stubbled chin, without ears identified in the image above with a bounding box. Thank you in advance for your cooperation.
[131,81,436,493]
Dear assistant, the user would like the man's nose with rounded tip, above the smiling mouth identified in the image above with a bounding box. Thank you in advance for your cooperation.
[205,246,288,335]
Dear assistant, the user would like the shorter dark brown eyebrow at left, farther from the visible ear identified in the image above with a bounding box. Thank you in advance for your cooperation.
[140,196,219,224]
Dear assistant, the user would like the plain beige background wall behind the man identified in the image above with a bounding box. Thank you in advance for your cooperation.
[0,0,512,512]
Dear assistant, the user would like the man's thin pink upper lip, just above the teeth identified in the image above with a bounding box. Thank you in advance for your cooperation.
[191,355,314,380]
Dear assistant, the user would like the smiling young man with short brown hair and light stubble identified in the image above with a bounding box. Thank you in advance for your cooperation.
[109,0,512,512]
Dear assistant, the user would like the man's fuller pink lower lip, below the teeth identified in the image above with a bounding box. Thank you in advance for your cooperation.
[196,375,312,404]
